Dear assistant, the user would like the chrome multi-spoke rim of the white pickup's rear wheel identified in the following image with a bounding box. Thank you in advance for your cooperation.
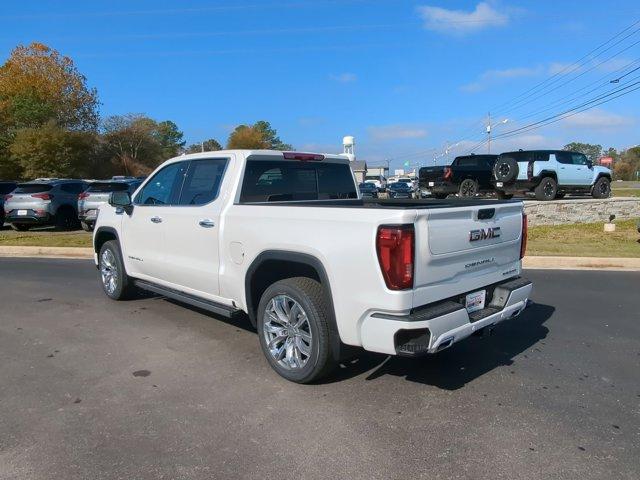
[262,295,312,370]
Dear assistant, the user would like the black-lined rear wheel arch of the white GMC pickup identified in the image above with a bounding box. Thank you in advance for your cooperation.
[245,250,338,333]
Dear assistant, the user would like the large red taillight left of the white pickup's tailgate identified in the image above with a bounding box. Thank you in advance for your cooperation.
[376,225,415,290]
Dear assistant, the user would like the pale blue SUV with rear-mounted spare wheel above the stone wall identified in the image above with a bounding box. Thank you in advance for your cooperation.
[493,150,611,200]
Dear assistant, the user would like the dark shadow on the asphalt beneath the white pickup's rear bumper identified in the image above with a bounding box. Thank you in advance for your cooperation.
[329,303,555,390]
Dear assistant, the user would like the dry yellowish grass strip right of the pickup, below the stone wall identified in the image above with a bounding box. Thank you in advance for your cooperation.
[527,220,640,257]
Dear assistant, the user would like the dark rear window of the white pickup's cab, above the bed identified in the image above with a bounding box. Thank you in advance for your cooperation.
[240,160,358,203]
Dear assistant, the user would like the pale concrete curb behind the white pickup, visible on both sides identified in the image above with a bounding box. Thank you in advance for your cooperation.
[0,246,640,271]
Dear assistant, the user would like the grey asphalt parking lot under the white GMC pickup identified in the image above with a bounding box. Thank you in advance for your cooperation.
[0,258,640,480]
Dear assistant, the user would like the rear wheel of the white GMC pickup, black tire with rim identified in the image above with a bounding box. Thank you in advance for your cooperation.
[256,277,339,383]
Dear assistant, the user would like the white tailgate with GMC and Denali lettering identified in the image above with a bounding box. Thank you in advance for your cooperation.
[414,203,522,307]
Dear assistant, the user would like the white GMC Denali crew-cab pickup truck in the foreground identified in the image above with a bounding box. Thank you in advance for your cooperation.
[93,150,532,383]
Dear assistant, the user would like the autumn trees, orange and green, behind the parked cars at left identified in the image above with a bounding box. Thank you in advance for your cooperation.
[0,43,292,179]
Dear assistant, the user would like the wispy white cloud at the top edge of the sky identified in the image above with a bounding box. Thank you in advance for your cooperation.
[418,2,509,35]
